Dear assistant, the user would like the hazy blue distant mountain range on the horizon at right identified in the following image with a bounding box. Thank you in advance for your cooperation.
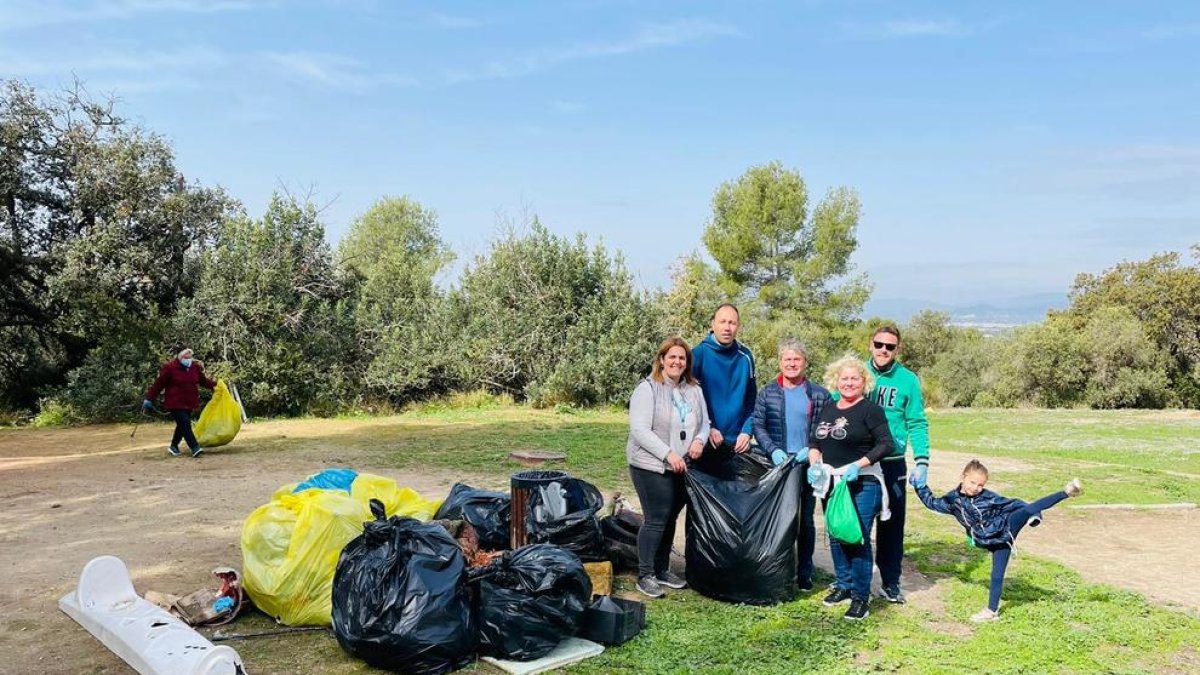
[863,293,1067,333]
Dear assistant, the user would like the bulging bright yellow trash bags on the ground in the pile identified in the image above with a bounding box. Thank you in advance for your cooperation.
[241,473,440,626]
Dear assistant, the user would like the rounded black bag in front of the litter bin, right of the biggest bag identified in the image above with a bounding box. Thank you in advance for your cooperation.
[469,544,592,661]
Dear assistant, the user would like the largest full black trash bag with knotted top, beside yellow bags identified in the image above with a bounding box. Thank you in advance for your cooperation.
[334,500,479,675]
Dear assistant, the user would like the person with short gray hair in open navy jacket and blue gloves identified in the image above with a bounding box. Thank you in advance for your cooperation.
[754,339,830,591]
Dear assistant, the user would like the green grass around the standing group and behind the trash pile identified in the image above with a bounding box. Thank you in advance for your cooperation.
[11,405,1200,674]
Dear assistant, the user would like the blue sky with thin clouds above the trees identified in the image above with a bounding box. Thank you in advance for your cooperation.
[0,0,1200,303]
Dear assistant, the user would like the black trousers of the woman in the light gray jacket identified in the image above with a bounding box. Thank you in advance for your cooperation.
[629,466,688,578]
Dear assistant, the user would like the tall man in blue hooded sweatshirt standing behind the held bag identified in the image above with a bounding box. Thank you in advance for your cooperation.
[691,303,757,476]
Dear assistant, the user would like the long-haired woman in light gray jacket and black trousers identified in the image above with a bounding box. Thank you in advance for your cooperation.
[625,338,709,598]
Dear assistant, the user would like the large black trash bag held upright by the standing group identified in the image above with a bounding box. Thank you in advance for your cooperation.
[684,454,802,604]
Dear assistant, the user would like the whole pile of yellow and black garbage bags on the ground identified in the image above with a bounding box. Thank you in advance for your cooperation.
[242,468,612,674]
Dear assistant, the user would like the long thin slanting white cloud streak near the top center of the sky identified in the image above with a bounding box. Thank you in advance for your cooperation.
[445,19,742,84]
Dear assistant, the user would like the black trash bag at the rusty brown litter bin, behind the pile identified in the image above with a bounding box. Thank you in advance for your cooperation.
[524,478,608,562]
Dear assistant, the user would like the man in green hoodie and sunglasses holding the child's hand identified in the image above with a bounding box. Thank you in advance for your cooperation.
[866,324,929,603]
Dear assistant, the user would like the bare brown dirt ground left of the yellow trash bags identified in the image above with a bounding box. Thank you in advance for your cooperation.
[0,420,465,674]
